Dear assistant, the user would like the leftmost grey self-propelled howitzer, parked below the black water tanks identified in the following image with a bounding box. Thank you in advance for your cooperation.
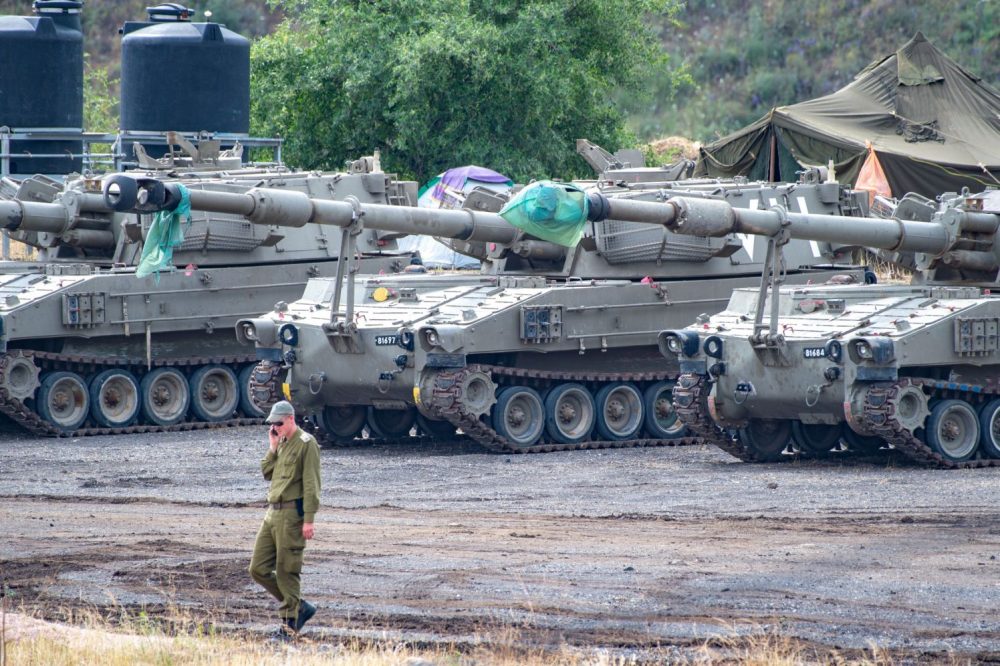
[0,144,416,435]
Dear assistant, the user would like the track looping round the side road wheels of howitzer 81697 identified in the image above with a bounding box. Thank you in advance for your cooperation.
[421,364,701,453]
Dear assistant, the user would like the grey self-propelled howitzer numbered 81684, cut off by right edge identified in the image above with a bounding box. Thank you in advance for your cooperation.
[660,187,1000,467]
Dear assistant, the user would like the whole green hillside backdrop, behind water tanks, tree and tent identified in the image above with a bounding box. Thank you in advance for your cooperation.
[0,0,1000,142]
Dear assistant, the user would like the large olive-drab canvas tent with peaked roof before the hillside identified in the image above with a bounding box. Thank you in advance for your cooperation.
[695,33,1000,196]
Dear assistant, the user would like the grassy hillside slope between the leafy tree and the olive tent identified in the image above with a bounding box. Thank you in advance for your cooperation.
[631,0,1000,141]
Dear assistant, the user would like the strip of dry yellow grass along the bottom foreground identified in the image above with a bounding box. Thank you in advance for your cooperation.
[0,608,944,666]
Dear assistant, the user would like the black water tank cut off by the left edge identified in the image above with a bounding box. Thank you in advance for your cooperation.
[0,0,83,174]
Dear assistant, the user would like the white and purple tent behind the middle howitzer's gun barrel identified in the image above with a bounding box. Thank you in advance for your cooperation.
[398,165,514,268]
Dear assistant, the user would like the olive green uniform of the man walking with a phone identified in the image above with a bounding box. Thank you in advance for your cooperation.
[250,429,320,620]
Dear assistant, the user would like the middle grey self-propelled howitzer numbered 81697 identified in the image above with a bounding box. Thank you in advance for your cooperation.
[109,172,880,451]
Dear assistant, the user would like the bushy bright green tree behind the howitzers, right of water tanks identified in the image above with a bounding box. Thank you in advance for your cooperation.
[251,0,678,182]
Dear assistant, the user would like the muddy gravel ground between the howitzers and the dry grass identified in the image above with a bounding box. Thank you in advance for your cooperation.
[0,428,1000,661]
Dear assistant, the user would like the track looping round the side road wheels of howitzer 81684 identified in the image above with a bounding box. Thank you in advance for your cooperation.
[863,378,1000,469]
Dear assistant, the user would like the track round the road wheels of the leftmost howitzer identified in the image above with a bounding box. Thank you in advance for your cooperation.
[0,351,264,437]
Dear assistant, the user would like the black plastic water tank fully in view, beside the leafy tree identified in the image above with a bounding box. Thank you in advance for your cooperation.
[121,3,250,134]
